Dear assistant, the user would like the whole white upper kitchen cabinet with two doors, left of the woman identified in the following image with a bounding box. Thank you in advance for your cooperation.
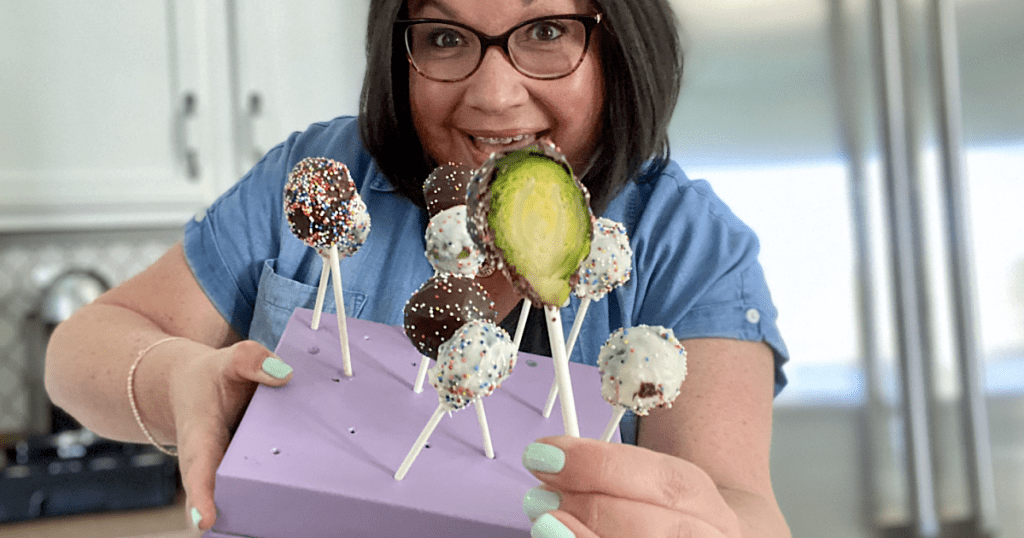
[0,0,367,233]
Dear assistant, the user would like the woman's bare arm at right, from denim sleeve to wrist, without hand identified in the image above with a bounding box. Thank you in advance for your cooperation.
[637,338,790,537]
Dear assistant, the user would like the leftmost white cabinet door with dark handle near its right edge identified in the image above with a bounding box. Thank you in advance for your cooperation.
[0,0,220,231]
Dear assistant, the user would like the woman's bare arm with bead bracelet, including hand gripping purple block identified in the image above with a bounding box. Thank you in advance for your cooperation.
[46,244,292,530]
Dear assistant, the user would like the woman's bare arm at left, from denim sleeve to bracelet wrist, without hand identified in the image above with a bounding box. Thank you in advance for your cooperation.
[46,243,239,444]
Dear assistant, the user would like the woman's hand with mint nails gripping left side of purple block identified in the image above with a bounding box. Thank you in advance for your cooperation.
[163,340,293,531]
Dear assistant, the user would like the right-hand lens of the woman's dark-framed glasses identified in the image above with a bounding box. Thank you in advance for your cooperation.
[509,18,587,78]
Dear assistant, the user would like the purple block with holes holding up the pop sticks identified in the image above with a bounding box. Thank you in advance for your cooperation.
[205,309,611,538]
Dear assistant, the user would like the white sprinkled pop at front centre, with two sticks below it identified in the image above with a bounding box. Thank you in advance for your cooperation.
[394,320,516,480]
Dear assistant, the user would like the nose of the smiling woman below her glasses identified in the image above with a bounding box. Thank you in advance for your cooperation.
[464,47,529,114]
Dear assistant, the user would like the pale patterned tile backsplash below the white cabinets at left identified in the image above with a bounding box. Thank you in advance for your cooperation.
[0,229,181,434]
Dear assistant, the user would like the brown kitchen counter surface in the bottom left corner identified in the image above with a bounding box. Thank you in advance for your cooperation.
[0,492,201,538]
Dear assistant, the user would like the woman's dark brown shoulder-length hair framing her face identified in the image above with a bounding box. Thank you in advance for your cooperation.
[359,0,683,215]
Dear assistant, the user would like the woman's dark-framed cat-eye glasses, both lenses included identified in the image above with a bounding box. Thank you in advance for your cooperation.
[395,13,601,82]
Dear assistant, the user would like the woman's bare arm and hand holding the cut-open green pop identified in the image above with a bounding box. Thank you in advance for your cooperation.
[522,339,790,538]
